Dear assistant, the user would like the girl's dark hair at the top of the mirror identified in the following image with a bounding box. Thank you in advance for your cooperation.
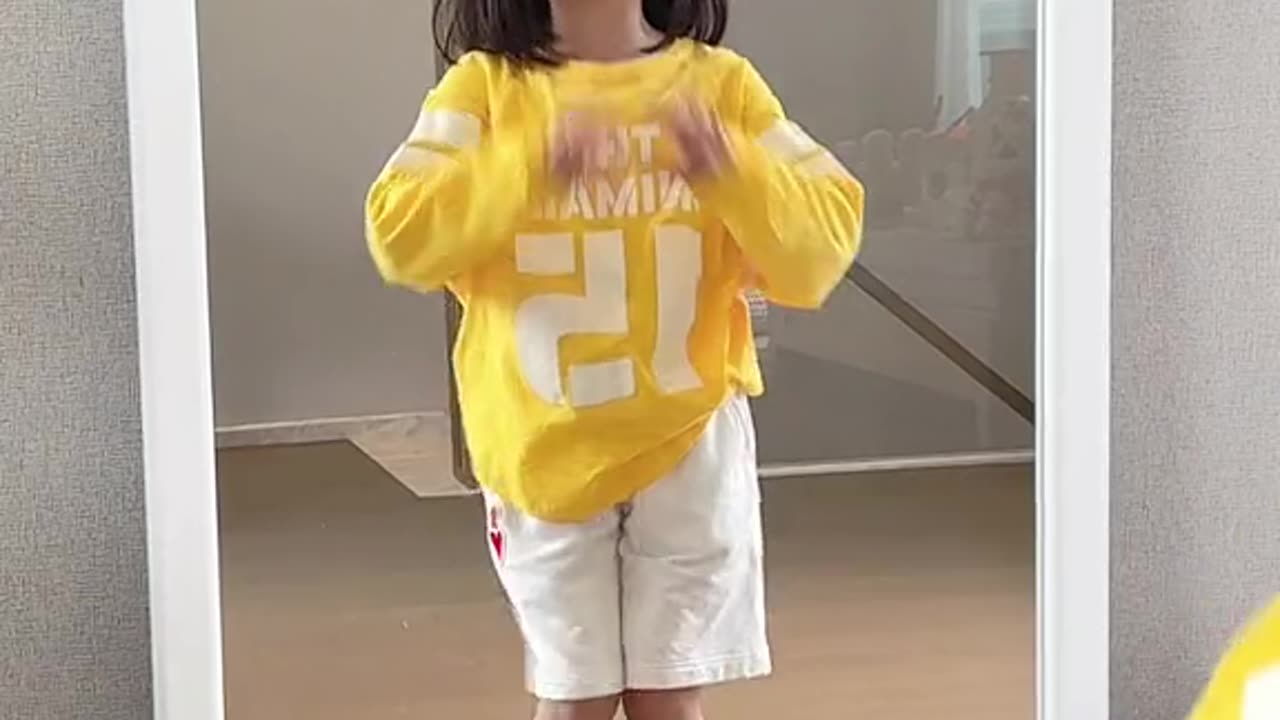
[431,0,728,64]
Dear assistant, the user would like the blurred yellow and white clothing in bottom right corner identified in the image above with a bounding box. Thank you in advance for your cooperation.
[1190,598,1280,720]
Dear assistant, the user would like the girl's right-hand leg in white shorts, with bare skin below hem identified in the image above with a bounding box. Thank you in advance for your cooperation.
[620,398,772,720]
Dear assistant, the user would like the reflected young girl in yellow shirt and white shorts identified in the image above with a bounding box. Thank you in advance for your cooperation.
[366,0,863,720]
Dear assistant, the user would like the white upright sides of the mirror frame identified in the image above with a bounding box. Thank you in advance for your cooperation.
[123,0,1111,720]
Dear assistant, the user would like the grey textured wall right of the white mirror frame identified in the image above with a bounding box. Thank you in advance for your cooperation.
[1111,0,1280,720]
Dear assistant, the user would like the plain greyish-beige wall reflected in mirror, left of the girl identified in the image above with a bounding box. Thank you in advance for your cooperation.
[198,0,448,427]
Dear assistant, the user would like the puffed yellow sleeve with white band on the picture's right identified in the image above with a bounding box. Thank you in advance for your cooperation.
[700,60,864,309]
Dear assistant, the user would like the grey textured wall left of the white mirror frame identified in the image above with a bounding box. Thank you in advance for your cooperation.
[0,0,151,720]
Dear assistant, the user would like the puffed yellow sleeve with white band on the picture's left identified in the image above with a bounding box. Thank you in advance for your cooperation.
[365,55,544,291]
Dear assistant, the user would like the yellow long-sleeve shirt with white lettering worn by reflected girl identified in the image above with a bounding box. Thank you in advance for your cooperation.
[366,41,863,521]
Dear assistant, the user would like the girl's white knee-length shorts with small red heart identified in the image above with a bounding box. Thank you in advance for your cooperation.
[485,398,771,701]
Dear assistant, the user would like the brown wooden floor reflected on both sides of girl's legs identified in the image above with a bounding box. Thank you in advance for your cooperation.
[219,443,1034,720]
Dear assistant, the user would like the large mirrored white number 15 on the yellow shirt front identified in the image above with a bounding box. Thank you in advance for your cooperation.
[516,225,703,407]
